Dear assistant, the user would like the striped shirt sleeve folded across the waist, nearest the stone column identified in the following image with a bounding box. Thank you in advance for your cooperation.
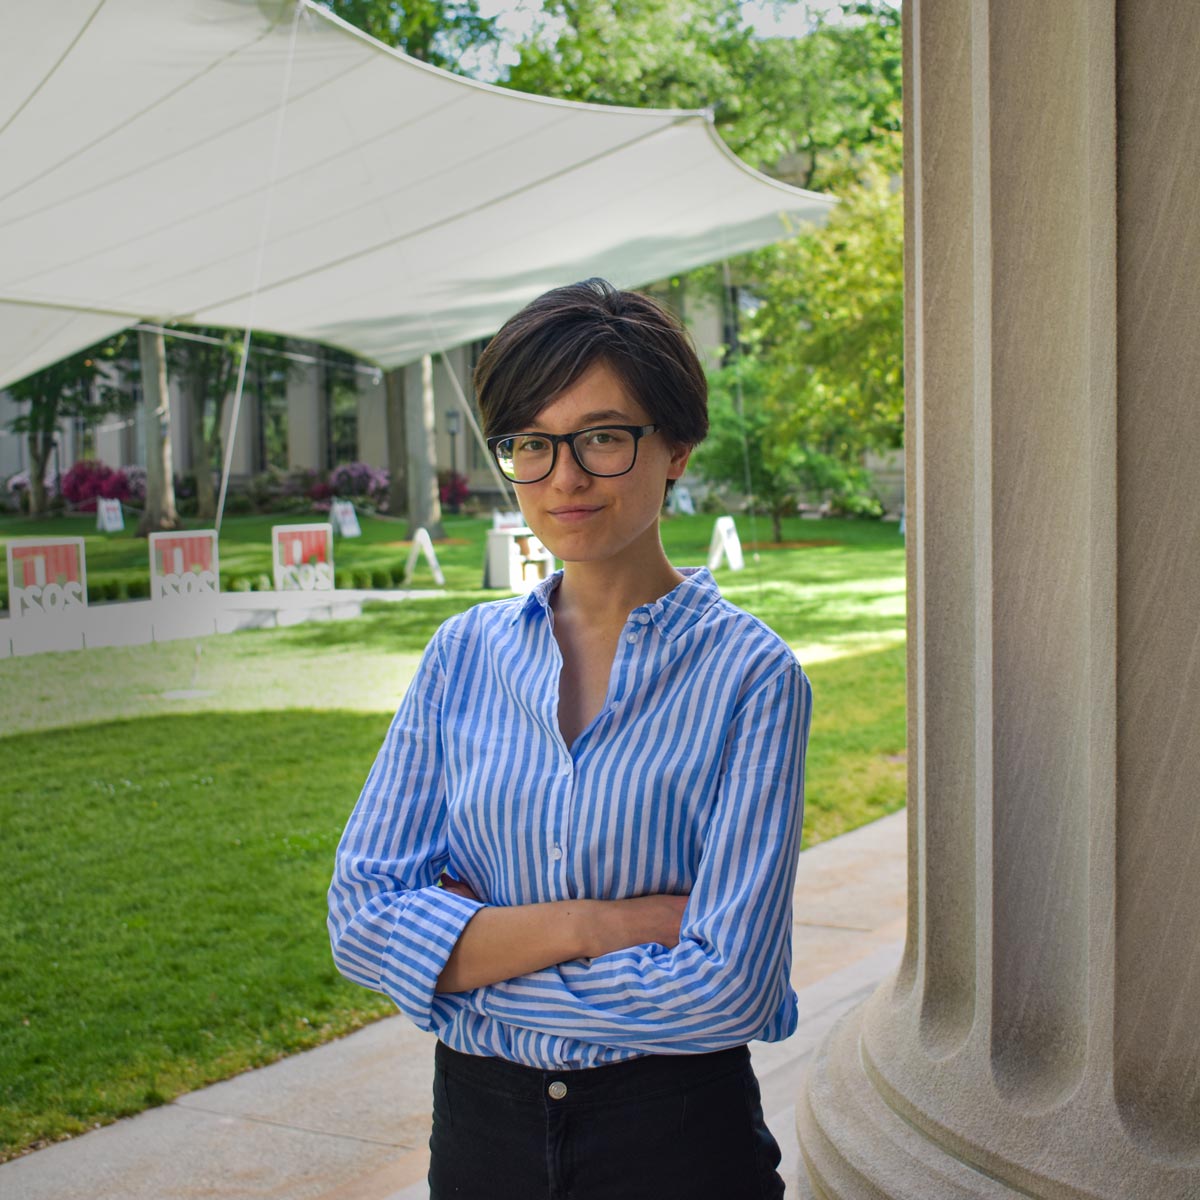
[473,662,811,1054]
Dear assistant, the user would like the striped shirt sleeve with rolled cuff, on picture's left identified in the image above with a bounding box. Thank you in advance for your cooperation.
[329,631,484,1030]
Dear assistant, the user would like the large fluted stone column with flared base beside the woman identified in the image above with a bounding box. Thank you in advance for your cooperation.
[797,0,1200,1200]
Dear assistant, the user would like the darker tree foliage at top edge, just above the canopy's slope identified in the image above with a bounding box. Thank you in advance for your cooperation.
[322,0,497,72]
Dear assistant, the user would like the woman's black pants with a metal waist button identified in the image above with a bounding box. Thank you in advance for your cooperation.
[430,1042,784,1200]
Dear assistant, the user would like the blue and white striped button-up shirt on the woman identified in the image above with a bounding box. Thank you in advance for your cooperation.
[329,570,811,1069]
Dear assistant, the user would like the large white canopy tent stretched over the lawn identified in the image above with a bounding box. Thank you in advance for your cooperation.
[0,0,833,386]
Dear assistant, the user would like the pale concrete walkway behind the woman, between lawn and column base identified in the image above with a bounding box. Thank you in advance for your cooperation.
[0,812,906,1200]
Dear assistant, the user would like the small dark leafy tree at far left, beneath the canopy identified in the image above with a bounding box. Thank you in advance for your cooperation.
[7,343,131,515]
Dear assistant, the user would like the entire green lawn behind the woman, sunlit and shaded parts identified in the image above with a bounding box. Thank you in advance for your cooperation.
[0,517,905,1159]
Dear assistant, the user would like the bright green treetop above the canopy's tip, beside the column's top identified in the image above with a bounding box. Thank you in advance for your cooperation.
[504,0,901,188]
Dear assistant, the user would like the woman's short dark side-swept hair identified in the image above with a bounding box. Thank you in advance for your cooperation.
[474,278,708,446]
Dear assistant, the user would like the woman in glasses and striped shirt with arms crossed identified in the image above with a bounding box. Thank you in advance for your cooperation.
[330,280,810,1200]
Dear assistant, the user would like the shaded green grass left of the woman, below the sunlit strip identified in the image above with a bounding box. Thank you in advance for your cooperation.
[0,712,400,1153]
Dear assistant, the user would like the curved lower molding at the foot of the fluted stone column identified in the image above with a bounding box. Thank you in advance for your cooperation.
[796,1004,1028,1200]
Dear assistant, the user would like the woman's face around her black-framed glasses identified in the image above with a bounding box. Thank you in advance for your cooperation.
[514,362,690,565]
